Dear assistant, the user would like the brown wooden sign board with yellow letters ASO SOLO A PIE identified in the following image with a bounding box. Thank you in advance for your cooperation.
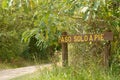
[59,32,113,43]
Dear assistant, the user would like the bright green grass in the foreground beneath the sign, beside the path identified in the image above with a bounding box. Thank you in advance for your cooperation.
[12,67,120,80]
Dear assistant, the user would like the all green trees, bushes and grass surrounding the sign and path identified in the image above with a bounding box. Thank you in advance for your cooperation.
[0,0,120,80]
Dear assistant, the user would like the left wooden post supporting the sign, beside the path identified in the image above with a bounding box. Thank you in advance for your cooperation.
[62,32,68,67]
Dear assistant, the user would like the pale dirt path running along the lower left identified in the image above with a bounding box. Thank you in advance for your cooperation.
[0,64,51,80]
